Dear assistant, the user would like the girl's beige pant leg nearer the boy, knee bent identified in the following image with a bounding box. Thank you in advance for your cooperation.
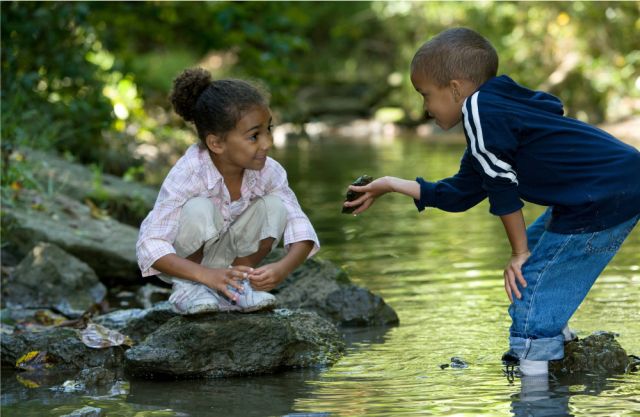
[202,195,287,268]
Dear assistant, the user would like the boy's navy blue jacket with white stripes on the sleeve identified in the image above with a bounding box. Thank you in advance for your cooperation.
[415,75,640,233]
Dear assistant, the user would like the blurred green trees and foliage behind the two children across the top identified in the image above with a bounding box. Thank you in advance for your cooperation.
[1,2,640,196]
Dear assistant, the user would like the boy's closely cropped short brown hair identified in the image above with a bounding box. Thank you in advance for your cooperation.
[411,28,498,87]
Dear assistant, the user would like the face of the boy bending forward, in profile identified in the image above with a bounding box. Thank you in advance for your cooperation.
[411,70,464,130]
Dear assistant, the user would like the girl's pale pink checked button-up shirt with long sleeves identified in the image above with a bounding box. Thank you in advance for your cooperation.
[136,144,320,276]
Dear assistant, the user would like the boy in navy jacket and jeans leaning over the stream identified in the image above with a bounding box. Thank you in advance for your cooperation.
[345,28,640,375]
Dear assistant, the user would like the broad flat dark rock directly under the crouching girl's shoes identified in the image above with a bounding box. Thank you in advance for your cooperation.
[125,310,344,378]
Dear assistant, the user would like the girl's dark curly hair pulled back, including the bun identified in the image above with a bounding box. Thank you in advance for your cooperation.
[170,68,269,144]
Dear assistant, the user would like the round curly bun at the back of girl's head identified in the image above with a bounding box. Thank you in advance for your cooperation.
[170,68,211,122]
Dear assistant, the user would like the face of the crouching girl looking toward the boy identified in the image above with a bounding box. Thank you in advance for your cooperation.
[209,105,273,170]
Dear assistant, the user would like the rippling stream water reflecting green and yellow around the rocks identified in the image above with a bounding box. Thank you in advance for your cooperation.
[2,138,640,417]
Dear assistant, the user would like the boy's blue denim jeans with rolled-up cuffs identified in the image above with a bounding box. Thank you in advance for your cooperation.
[509,208,640,361]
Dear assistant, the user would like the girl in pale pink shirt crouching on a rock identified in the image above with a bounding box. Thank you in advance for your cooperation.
[136,69,320,314]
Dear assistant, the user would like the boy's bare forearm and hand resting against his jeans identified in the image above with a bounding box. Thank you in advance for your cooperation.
[500,210,531,302]
